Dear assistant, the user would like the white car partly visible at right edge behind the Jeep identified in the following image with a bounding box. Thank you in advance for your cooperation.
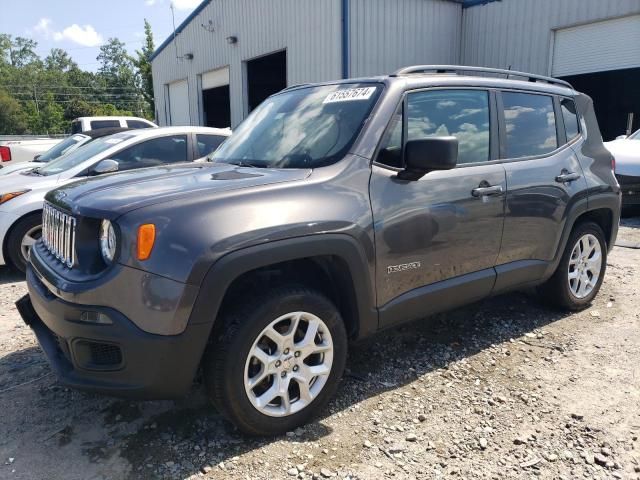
[604,130,640,207]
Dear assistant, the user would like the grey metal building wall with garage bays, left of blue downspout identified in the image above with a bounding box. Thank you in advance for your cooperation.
[153,0,341,126]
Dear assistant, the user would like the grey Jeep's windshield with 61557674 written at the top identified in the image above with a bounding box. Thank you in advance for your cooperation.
[208,83,382,168]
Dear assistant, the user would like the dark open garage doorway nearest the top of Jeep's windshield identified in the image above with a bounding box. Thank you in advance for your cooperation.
[247,50,287,112]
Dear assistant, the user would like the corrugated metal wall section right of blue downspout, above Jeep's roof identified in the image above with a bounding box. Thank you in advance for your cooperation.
[349,0,462,77]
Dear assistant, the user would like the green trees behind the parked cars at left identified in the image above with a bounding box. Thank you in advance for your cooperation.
[0,25,154,135]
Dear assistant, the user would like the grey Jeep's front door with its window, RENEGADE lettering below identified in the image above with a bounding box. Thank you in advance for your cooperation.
[370,89,506,326]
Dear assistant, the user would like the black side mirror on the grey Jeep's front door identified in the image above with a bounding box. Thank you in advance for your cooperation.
[398,136,458,180]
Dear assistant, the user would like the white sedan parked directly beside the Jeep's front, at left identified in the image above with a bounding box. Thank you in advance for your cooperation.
[0,127,231,271]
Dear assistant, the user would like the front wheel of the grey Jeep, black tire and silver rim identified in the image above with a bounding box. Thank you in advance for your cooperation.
[203,286,347,436]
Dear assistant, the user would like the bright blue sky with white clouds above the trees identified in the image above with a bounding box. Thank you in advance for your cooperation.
[0,0,201,71]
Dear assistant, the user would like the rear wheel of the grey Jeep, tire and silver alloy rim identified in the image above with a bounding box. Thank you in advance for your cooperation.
[538,222,607,311]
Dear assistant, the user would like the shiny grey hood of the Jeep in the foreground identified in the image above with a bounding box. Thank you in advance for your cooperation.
[46,163,311,219]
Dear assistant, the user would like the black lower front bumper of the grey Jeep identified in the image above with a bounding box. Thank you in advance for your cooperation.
[16,265,211,399]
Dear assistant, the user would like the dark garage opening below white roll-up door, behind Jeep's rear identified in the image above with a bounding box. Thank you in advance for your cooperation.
[562,68,640,141]
